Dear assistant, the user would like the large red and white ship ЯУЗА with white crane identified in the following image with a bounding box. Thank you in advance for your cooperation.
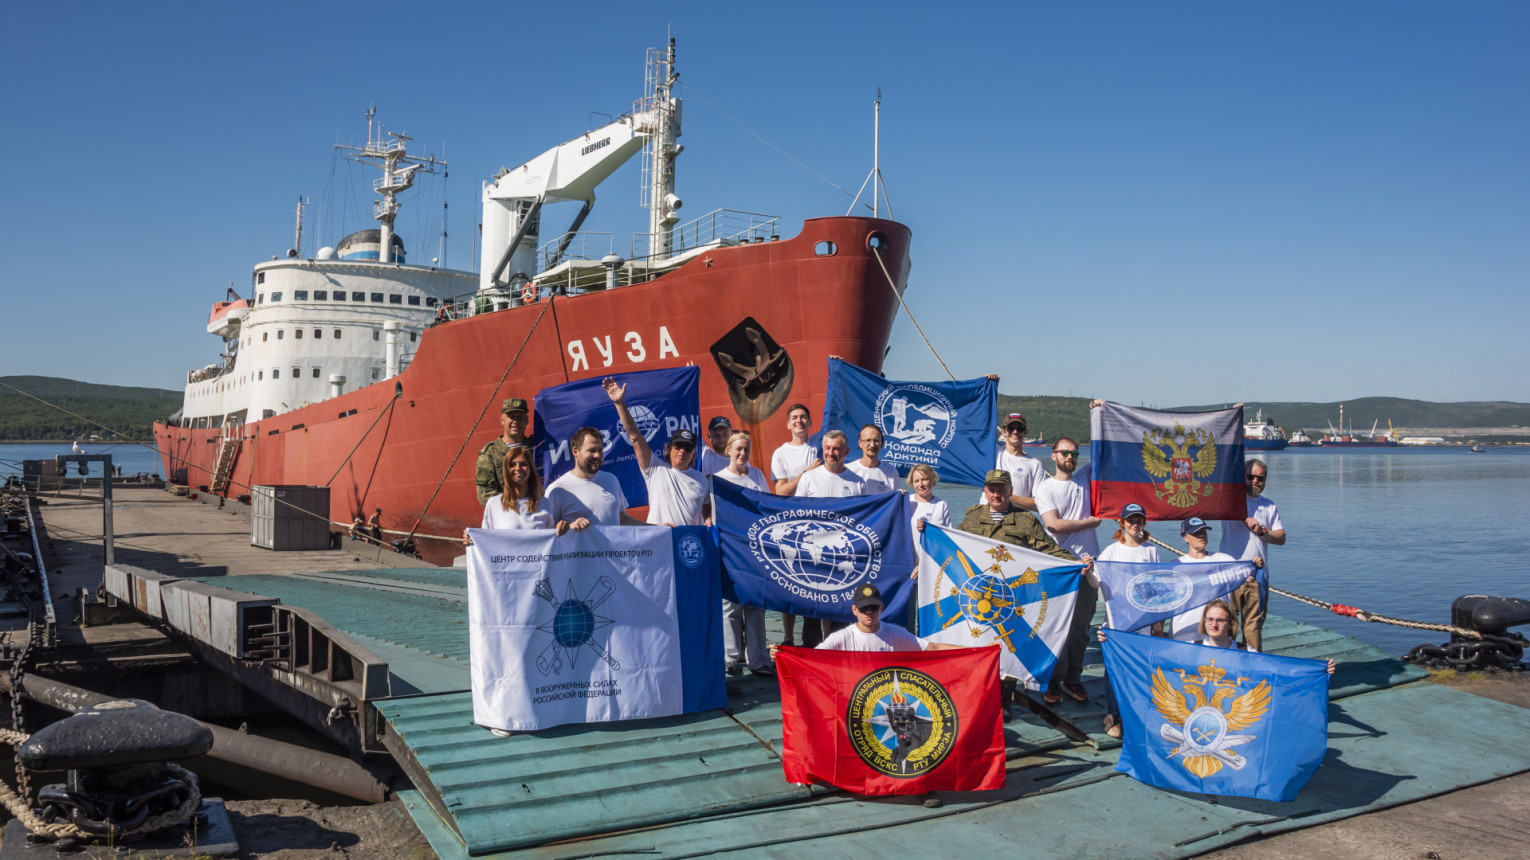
[155,40,912,563]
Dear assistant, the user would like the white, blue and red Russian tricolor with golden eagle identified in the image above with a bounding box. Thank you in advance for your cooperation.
[1089,402,1248,520]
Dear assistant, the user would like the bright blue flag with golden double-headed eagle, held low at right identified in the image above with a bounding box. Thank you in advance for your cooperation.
[1105,621,1328,800]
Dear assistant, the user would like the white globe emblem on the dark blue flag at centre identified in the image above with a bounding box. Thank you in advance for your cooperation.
[754,519,880,591]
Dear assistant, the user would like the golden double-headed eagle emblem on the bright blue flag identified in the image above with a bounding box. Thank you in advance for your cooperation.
[1152,660,1270,779]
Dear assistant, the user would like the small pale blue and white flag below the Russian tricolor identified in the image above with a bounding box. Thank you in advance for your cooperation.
[1094,560,1265,630]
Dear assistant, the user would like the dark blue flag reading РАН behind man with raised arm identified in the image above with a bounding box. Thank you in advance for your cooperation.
[532,367,701,508]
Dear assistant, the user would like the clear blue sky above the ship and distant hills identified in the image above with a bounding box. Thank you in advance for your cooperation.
[0,2,1530,406]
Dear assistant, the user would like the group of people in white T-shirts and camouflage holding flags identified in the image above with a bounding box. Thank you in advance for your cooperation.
[464,390,1315,736]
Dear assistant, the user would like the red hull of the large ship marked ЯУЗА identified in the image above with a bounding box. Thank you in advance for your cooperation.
[155,217,910,562]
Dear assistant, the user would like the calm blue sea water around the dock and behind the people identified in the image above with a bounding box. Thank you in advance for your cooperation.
[0,444,1530,653]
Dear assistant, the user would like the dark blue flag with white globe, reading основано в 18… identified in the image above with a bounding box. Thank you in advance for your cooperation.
[711,480,915,623]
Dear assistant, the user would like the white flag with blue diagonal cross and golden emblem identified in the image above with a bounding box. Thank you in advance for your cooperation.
[918,525,1083,690]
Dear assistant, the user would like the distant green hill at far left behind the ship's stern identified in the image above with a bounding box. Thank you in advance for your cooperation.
[0,376,182,442]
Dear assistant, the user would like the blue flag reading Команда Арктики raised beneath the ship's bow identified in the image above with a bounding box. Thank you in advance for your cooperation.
[822,358,999,485]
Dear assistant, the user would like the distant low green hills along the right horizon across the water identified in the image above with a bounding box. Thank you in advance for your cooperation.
[999,395,1530,442]
